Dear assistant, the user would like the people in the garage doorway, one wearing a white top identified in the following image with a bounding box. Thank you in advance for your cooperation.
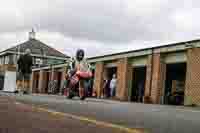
[103,74,117,98]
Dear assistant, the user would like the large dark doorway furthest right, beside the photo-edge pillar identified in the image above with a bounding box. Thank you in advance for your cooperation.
[164,63,186,105]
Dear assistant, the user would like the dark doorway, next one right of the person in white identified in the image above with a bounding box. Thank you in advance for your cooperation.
[131,66,146,103]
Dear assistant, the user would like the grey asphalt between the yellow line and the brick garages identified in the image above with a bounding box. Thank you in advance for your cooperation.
[0,92,200,133]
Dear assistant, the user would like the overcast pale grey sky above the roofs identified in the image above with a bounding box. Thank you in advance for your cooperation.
[0,0,200,56]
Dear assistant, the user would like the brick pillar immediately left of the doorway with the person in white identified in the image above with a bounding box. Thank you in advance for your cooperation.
[94,62,104,98]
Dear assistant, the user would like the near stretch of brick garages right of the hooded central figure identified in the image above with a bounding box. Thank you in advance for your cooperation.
[33,40,200,105]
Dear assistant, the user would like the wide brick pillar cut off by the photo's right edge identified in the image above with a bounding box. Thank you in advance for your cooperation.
[184,48,200,105]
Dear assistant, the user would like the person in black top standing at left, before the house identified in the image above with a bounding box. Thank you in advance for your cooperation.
[17,49,33,94]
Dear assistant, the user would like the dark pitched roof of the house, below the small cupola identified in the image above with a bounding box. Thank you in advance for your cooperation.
[4,39,69,58]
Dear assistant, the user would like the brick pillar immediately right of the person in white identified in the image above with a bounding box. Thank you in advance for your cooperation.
[116,58,132,100]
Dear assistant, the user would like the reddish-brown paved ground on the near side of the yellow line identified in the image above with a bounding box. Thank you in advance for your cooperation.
[0,96,142,133]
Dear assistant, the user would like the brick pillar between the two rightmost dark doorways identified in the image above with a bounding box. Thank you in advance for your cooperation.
[151,53,166,104]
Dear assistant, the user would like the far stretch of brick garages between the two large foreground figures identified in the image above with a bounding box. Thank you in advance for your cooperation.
[31,64,68,94]
